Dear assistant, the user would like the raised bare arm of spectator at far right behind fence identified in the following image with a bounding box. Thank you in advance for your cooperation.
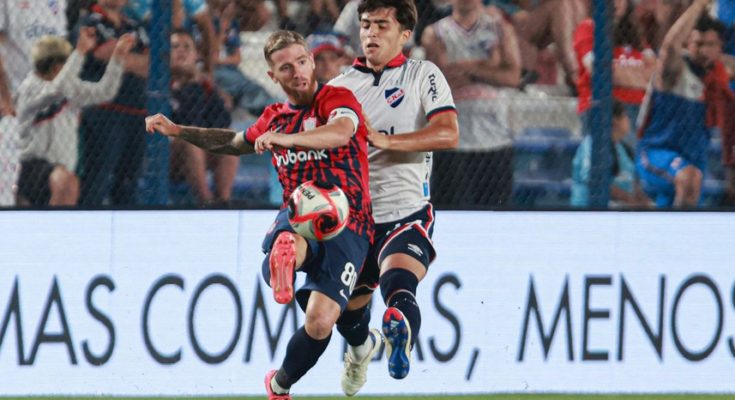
[655,0,711,90]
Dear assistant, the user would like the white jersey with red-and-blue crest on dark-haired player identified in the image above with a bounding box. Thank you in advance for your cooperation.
[329,54,456,223]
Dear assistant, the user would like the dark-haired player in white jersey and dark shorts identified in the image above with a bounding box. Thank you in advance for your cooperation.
[330,0,459,396]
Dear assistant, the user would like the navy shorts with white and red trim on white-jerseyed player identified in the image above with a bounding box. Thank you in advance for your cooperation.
[355,203,436,295]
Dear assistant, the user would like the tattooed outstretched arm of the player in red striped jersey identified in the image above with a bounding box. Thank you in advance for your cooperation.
[145,114,255,155]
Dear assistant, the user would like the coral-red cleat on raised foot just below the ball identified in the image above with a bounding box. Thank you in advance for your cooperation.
[268,231,296,304]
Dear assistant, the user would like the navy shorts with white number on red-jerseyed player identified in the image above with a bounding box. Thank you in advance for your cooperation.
[262,209,370,310]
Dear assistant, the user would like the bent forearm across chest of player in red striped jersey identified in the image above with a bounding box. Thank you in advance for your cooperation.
[255,118,355,154]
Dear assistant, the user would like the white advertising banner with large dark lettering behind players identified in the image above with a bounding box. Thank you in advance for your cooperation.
[0,211,735,395]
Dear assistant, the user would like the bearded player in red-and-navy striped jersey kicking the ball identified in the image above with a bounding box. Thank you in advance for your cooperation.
[146,31,374,400]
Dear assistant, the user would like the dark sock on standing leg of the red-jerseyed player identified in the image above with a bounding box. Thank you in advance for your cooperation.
[276,326,332,389]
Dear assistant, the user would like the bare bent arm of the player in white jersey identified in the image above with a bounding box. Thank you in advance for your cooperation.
[368,112,459,151]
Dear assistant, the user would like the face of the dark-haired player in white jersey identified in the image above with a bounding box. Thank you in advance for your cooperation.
[360,7,411,69]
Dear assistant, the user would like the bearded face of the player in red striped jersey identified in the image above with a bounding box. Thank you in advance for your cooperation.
[268,44,316,99]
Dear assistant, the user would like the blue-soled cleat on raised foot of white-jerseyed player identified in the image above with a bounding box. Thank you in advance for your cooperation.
[383,307,411,379]
